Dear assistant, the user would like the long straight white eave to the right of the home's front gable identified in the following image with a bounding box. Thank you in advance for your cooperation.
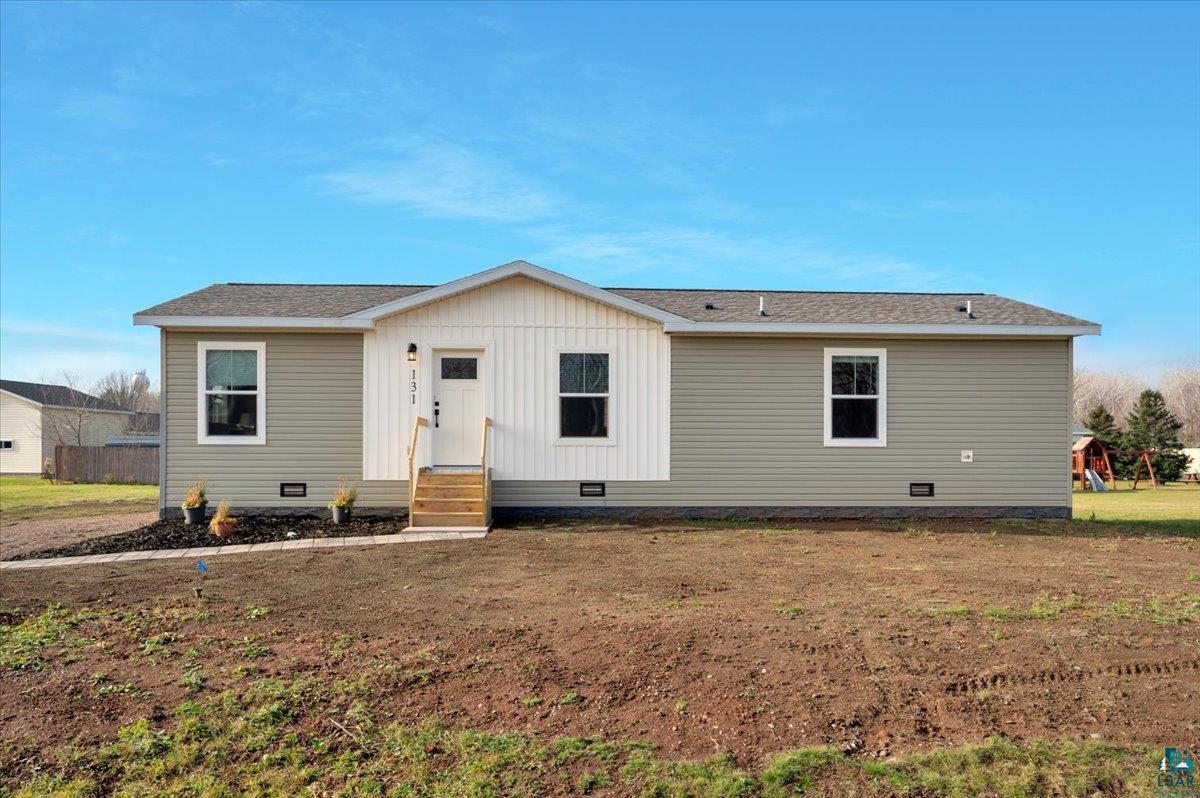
[662,322,1100,338]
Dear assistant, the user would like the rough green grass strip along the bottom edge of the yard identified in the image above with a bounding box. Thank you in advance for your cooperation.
[4,678,1158,798]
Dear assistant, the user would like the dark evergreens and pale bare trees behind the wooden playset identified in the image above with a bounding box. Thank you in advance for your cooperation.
[1074,368,1200,481]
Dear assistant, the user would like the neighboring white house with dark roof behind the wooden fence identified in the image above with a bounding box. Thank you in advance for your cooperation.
[0,379,133,474]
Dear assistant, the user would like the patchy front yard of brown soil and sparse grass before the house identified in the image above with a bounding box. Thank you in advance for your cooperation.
[0,520,1200,798]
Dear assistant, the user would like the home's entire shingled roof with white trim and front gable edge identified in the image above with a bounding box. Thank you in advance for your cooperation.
[133,260,1099,336]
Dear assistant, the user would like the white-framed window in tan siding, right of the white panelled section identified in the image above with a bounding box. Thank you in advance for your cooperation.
[824,348,888,446]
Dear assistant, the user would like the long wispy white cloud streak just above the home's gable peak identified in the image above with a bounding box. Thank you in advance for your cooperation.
[322,140,946,290]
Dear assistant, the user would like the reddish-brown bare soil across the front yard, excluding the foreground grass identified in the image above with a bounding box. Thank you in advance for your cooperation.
[0,522,1200,769]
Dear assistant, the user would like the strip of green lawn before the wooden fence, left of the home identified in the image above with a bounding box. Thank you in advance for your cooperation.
[0,476,158,524]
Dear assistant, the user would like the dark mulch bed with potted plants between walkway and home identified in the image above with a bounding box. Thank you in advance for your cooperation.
[11,515,408,559]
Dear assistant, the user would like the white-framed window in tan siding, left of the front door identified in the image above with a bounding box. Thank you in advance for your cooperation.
[197,341,266,444]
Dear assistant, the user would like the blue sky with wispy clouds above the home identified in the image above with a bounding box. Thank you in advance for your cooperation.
[0,2,1200,379]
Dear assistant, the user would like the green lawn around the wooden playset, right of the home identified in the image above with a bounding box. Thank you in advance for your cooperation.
[1075,480,1200,536]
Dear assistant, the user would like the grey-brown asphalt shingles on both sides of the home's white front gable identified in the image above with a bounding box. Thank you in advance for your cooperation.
[139,283,1092,326]
